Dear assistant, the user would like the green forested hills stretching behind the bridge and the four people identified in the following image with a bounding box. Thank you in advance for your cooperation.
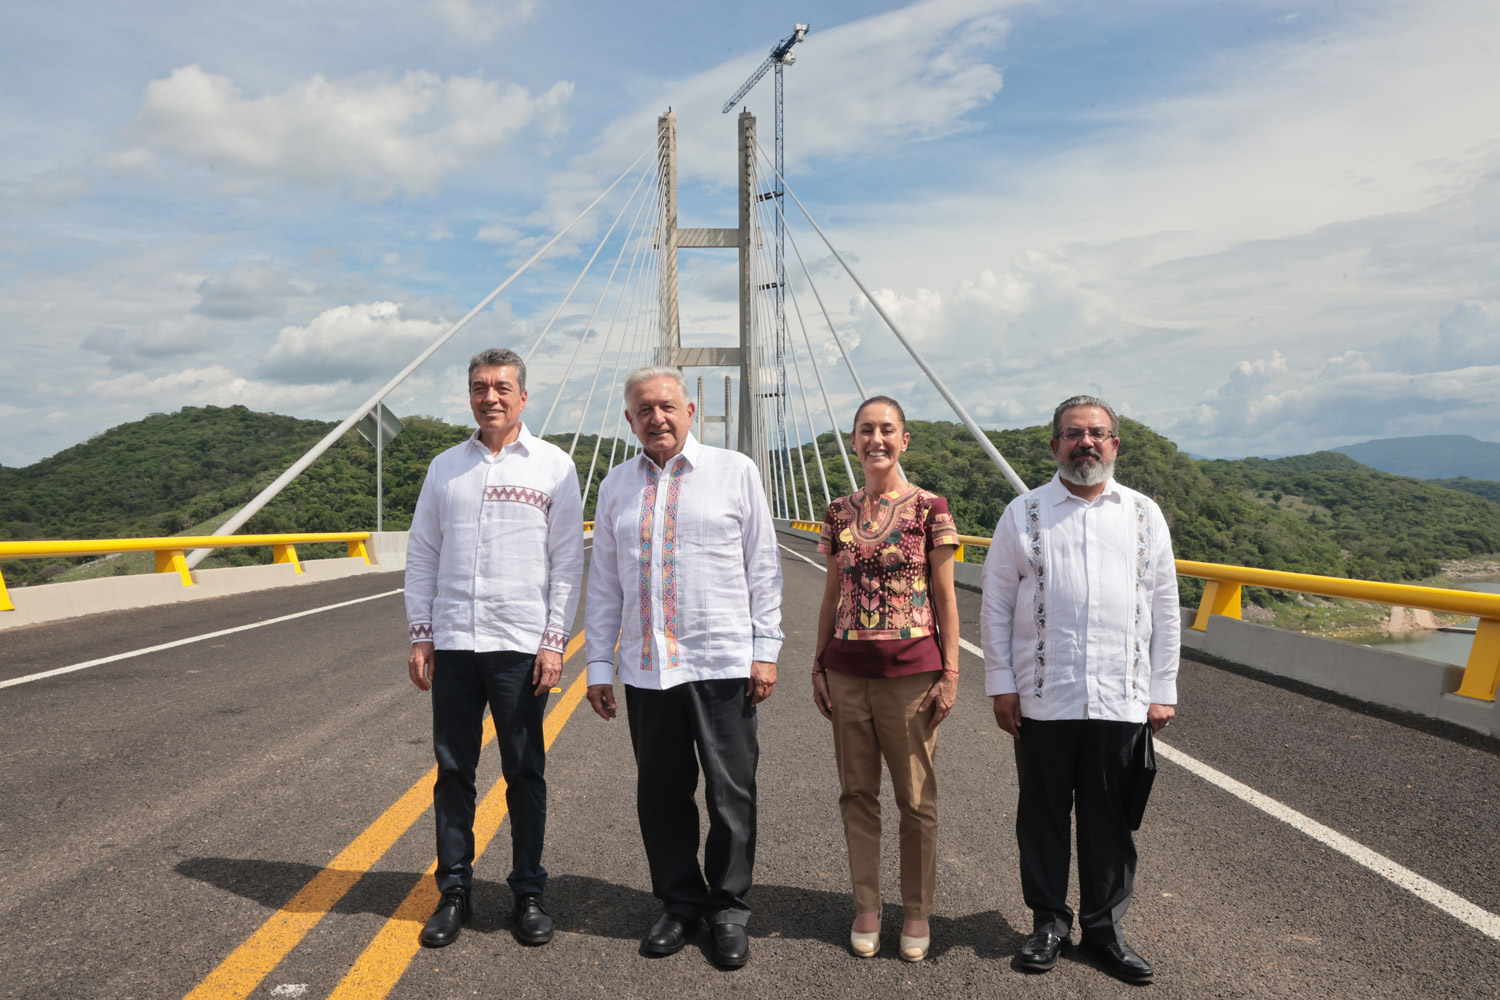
[0,406,1500,601]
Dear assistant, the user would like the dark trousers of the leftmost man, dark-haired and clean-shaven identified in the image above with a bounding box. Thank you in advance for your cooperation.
[432,649,548,895]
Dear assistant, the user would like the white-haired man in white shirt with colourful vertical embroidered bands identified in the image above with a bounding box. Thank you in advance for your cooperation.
[584,367,782,969]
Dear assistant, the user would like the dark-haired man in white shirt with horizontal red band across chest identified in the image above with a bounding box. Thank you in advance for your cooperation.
[407,348,584,948]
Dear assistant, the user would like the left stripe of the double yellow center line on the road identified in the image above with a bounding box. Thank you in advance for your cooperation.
[185,633,584,1000]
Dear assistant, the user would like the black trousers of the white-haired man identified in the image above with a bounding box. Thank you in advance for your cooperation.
[626,678,761,925]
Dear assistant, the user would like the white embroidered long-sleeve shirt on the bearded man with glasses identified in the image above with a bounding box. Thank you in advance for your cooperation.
[980,475,1182,723]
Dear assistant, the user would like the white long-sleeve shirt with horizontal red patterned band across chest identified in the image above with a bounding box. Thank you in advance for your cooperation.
[407,424,584,652]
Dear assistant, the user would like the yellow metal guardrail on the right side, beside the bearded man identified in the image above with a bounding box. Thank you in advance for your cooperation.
[959,535,1500,702]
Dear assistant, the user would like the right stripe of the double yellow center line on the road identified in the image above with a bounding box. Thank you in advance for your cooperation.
[329,659,588,1000]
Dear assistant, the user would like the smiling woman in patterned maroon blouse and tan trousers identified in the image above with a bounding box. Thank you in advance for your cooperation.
[813,396,959,961]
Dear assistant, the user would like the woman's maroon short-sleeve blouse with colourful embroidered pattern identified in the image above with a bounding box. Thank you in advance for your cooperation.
[818,483,959,678]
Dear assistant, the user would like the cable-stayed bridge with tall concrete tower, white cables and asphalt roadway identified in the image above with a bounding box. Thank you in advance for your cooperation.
[0,114,1500,997]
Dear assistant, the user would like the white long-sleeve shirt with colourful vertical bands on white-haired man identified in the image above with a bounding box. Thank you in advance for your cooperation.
[584,435,783,690]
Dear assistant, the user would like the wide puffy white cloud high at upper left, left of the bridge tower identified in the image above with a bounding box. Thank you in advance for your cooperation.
[111,64,573,198]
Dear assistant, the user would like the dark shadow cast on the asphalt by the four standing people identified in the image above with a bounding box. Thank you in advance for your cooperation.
[176,858,1026,958]
